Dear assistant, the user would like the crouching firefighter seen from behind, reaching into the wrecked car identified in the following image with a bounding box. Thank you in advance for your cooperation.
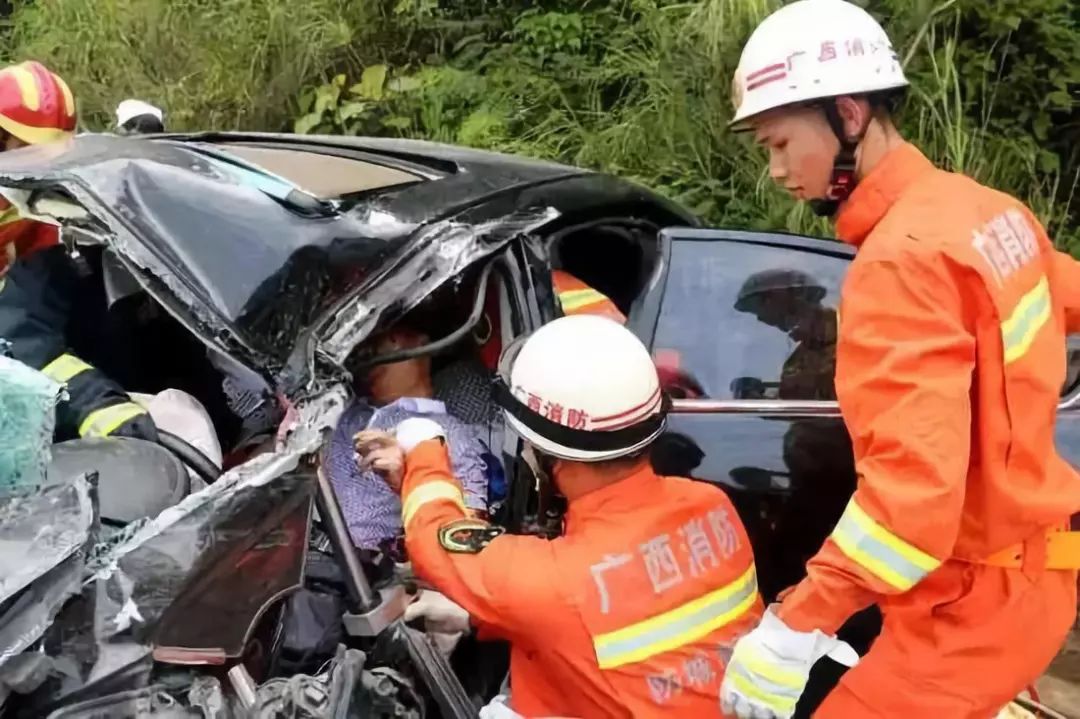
[359,315,762,717]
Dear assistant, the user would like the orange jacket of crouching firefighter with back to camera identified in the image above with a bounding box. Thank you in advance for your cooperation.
[402,440,762,718]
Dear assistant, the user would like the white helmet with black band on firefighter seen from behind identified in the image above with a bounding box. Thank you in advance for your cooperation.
[497,314,667,462]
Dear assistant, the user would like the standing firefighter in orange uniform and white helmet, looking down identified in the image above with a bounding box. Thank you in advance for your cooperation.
[721,0,1080,719]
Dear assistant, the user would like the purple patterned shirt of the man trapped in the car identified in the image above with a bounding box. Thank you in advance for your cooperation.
[325,397,487,550]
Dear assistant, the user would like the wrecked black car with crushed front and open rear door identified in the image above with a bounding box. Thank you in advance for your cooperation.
[0,134,1071,719]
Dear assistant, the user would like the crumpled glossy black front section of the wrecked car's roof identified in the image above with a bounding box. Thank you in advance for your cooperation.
[0,135,550,382]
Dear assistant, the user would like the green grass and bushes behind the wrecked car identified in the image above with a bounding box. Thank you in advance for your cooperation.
[9,0,1080,245]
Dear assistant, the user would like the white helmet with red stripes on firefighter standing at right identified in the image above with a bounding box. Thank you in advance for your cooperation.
[731,0,908,130]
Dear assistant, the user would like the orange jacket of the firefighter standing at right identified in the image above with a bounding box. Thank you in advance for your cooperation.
[780,140,1080,633]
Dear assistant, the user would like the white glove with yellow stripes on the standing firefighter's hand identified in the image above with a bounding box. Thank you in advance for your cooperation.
[720,607,853,719]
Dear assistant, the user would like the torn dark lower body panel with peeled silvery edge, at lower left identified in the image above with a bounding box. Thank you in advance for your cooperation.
[13,388,347,716]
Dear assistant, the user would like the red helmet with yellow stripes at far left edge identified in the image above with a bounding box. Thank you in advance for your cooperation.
[0,60,75,145]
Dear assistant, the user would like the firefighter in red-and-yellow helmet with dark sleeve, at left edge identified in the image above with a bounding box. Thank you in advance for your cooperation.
[0,62,157,439]
